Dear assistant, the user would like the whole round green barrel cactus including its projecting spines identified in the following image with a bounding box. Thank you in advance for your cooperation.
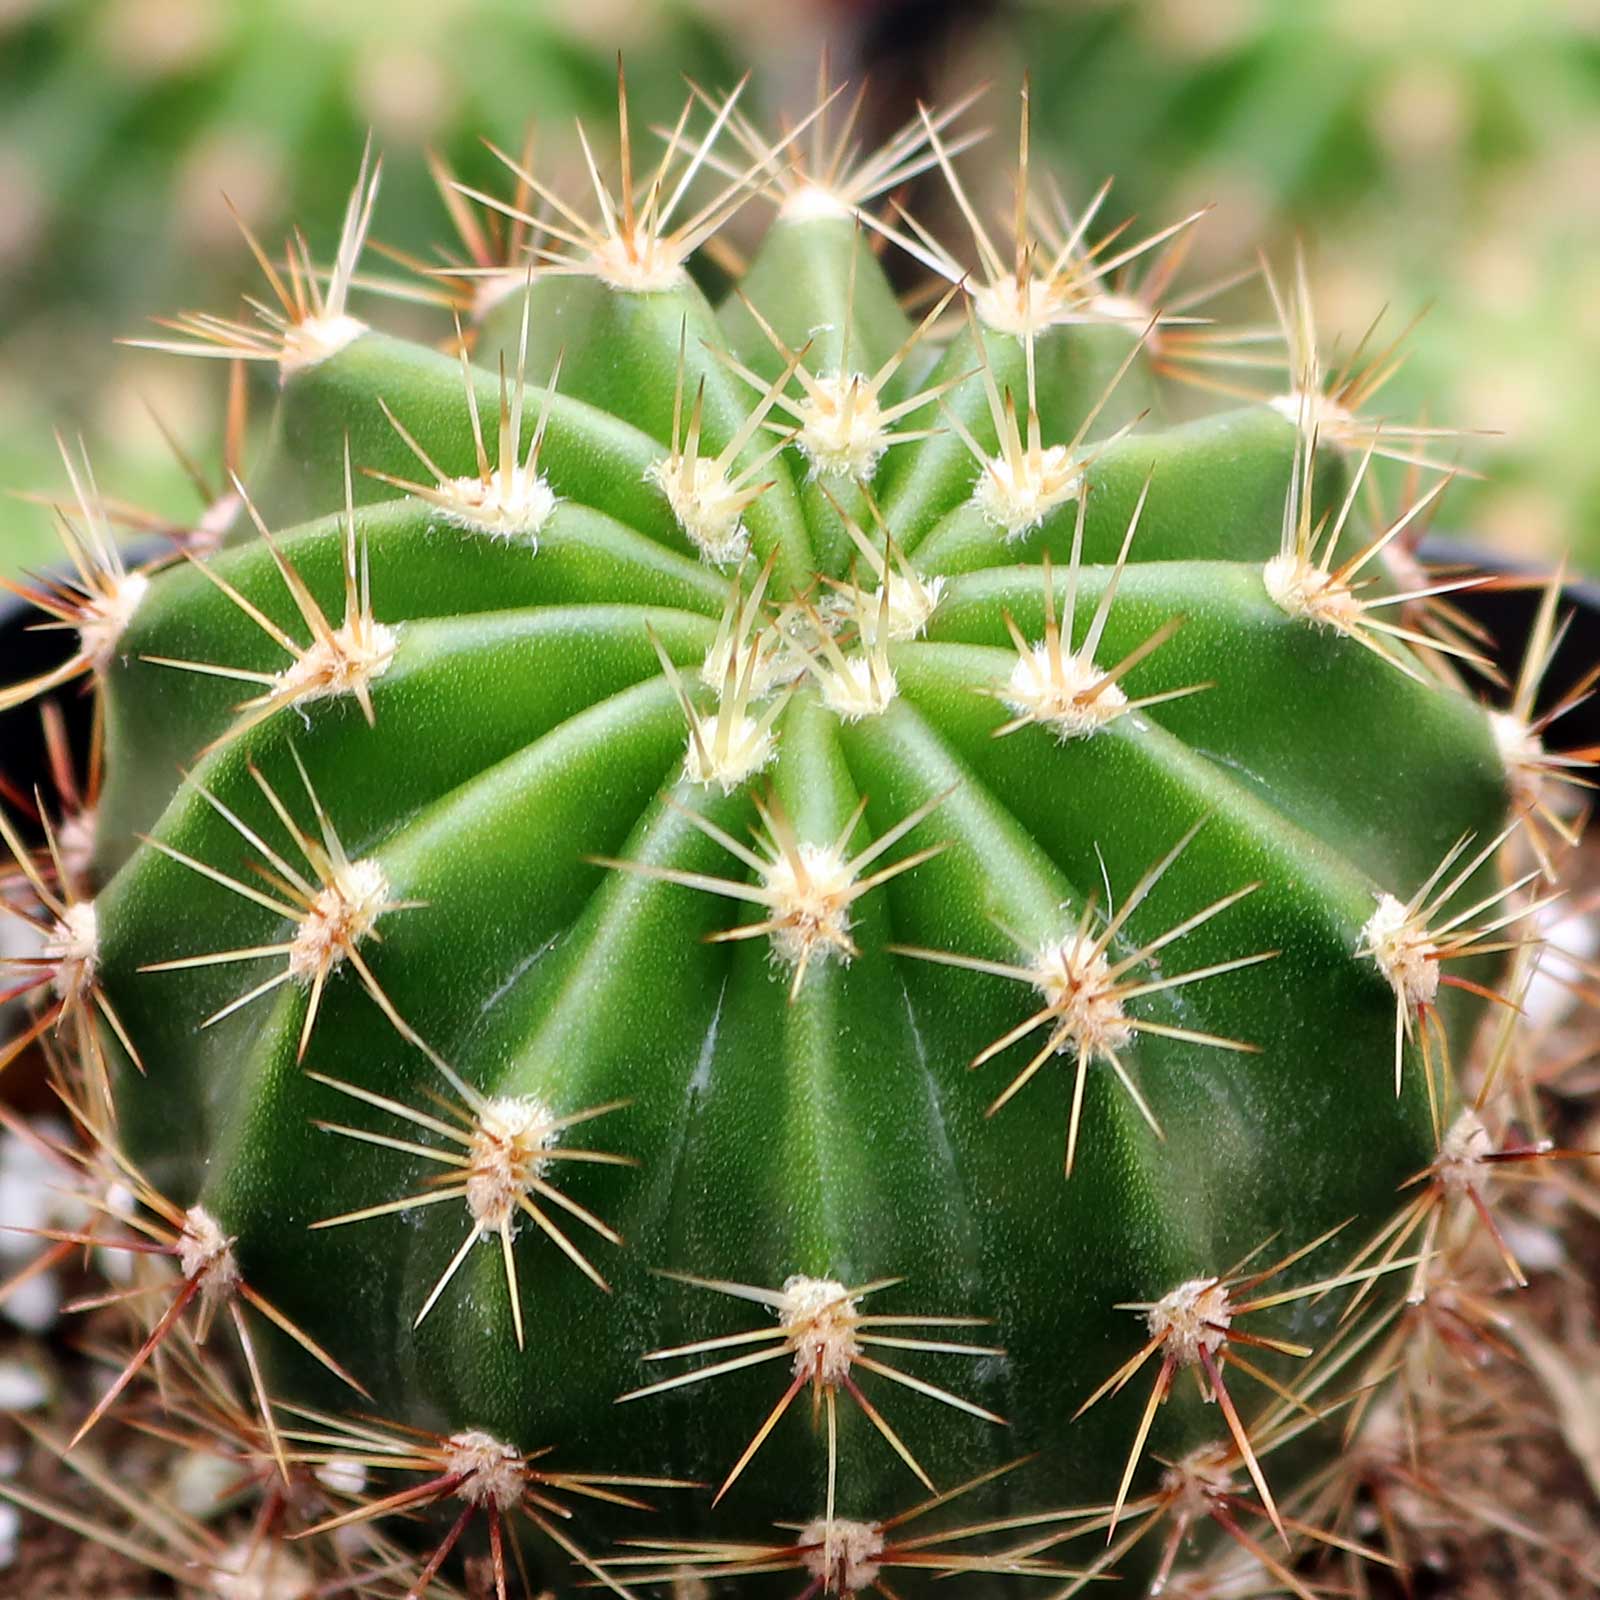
[6,68,1558,1595]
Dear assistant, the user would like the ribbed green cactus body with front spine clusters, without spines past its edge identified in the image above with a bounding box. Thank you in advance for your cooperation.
[3,84,1507,1595]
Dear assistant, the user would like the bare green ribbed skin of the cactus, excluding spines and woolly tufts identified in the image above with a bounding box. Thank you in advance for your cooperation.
[99,212,1507,1595]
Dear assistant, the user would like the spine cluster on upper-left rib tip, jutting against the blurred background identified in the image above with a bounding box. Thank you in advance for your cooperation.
[126,139,382,381]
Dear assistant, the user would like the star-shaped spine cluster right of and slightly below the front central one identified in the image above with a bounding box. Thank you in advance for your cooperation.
[890,818,1278,1178]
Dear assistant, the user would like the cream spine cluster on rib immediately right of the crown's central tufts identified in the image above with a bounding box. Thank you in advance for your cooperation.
[984,480,1214,742]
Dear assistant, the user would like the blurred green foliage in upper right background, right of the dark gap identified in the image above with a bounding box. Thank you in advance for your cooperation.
[995,0,1600,570]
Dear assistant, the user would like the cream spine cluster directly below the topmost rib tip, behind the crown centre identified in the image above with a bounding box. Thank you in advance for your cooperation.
[723,275,971,483]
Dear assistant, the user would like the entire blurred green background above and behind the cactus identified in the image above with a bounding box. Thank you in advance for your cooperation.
[0,0,1600,571]
